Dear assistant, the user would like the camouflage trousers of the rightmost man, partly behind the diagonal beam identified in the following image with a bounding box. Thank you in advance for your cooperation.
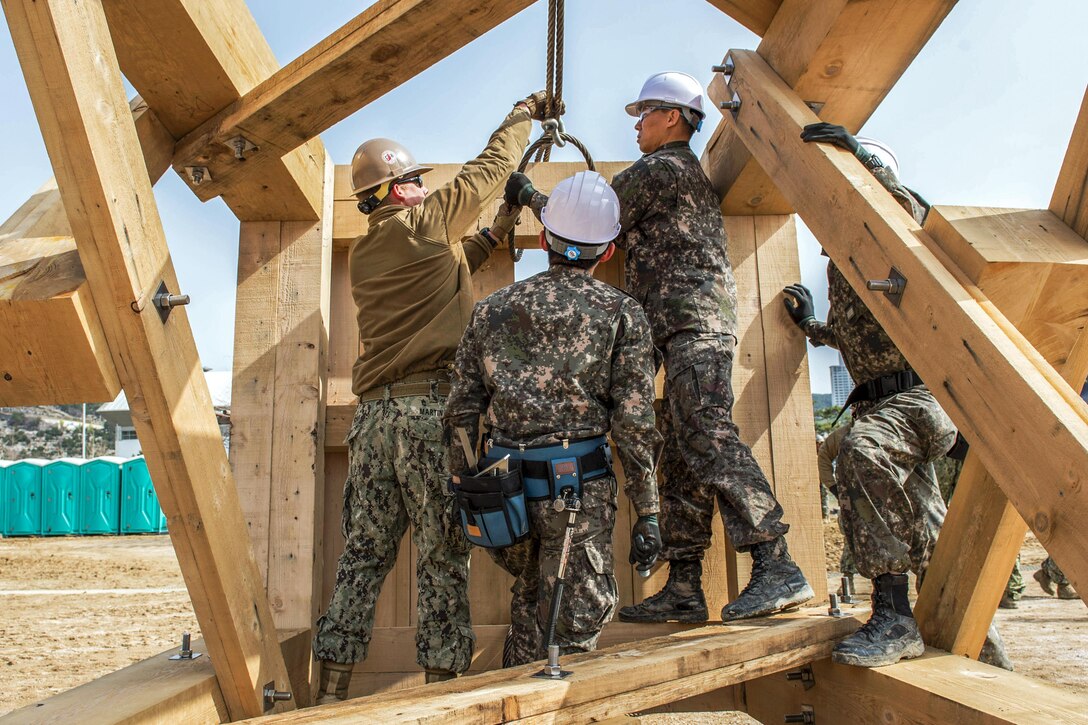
[836,385,955,579]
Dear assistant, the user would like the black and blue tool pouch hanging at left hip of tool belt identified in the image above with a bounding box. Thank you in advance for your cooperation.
[450,458,529,549]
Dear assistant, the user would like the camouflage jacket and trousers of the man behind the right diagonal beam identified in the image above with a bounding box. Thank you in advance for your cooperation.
[802,167,955,579]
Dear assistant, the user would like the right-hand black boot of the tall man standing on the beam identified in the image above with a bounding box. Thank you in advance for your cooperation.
[721,537,815,622]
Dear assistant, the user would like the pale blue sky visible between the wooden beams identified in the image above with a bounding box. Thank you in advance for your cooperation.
[0,0,1088,392]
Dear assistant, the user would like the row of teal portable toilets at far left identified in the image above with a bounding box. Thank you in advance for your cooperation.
[0,456,166,537]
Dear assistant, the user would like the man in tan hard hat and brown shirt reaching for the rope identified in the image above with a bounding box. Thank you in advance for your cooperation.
[313,91,545,704]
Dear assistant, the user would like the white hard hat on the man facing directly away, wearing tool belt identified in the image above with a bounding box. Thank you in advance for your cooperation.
[541,171,619,259]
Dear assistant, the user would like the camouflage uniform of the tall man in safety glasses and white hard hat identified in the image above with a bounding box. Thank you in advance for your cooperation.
[613,142,789,562]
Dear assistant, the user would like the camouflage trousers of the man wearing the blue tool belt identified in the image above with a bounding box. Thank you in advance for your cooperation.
[489,477,618,667]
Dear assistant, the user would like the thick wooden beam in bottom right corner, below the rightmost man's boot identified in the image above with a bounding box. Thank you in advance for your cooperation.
[743,648,1088,725]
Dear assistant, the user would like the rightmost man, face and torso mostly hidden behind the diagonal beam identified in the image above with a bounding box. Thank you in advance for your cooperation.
[783,123,1012,669]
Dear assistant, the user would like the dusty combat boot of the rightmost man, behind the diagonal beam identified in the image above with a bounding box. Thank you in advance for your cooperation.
[831,574,926,667]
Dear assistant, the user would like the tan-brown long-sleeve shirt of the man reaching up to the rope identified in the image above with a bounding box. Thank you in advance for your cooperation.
[349,107,532,395]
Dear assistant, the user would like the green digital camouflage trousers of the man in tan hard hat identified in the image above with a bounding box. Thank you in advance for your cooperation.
[313,388,475,673]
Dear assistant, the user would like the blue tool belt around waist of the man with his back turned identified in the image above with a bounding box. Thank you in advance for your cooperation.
[480,435,613,501]
